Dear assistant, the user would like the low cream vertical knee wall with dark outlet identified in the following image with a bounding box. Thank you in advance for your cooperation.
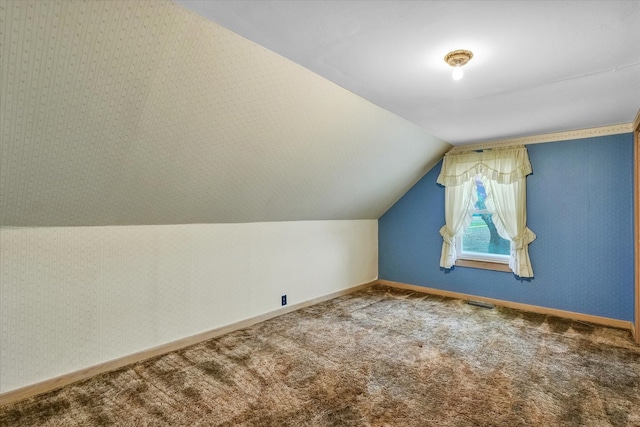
[0,220,378,393]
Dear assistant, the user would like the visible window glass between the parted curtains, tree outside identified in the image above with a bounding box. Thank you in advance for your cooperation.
[456,174,511,264]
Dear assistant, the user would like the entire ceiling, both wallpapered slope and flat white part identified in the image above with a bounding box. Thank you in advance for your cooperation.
[0,0,640,227]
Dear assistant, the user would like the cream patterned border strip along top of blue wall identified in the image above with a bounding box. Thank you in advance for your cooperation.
[449,122,640,153]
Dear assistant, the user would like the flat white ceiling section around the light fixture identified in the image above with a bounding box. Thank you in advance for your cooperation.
[177,0,640,145]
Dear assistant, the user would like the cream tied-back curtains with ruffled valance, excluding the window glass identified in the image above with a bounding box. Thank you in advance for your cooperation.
[437,147,536,277]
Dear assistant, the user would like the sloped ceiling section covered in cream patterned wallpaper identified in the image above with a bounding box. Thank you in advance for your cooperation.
[0,0,450,226]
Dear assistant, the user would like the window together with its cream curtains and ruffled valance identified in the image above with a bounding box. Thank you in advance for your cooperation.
[438,147,536,277]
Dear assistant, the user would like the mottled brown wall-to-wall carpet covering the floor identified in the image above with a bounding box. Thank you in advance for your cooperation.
[0,286,640,427]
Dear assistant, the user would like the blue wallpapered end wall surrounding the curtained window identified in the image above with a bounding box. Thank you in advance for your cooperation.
[378,133,634,321]
